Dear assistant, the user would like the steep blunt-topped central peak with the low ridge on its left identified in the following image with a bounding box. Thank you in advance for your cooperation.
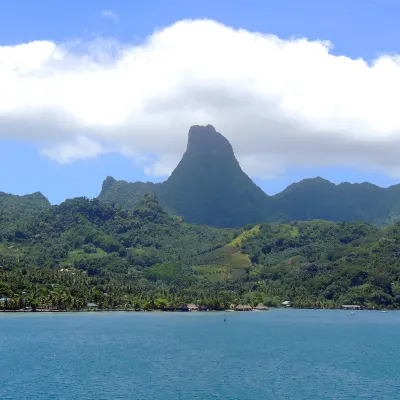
[99,125,279,227]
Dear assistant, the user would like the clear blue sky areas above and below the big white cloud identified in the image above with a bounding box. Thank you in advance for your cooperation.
[0,0,400,203]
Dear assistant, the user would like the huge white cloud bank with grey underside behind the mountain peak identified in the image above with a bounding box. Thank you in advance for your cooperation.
[0,20,400,177]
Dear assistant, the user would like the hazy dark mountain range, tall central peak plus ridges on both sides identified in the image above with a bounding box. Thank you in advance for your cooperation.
[99,125,400,227]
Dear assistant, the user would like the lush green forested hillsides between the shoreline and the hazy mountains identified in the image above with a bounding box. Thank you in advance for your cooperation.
[0,191,400,310]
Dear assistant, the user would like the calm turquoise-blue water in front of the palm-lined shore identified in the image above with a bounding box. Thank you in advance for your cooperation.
[0,310,400,400]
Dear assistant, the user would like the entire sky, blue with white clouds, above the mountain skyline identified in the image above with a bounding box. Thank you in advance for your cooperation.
[0,0,400,204]
